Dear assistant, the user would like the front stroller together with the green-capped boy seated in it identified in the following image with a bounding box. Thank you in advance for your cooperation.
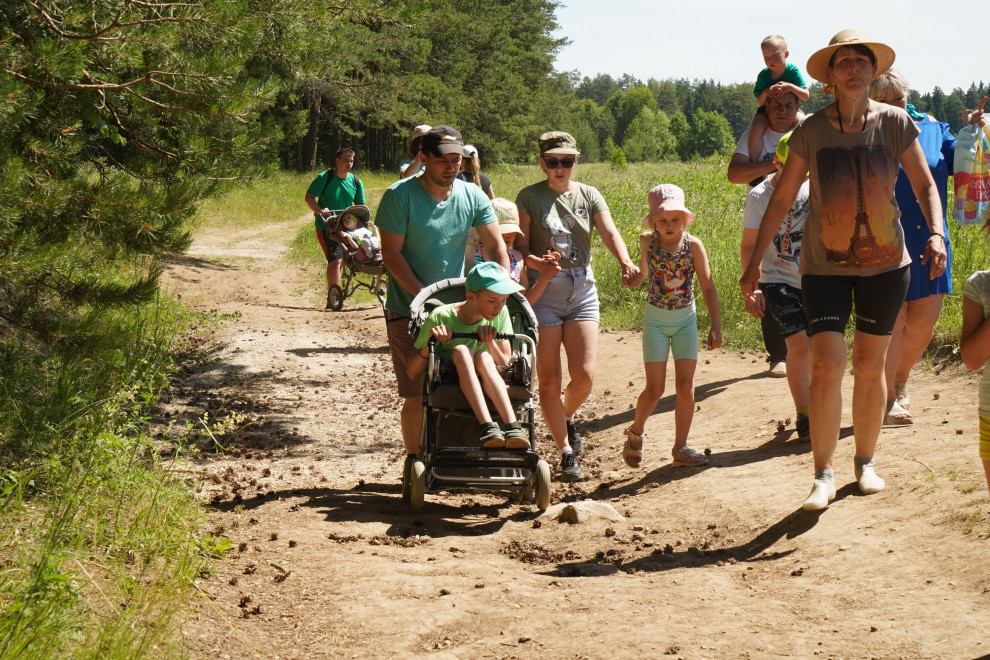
[402,262,550,510]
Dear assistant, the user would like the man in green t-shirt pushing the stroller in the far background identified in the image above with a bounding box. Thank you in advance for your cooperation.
[306,148,365,309]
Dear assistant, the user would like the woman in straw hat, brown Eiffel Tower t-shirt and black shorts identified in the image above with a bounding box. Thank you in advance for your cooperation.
[740,30,946,509]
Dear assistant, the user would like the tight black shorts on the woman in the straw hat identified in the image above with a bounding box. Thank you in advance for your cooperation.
[801,266,911,336]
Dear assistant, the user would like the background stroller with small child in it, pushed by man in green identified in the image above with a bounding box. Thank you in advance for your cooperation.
[326,205,388,312]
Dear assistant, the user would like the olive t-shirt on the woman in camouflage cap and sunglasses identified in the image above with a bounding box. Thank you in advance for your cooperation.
[516,181,608,269]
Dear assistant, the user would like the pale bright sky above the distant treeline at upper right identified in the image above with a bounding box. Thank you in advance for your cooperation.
[555,0,990,93]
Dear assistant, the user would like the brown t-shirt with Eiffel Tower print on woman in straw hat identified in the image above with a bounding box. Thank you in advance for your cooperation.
[789,104,918,275]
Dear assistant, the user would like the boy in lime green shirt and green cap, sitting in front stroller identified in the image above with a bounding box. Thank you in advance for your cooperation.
[408,261,530,449]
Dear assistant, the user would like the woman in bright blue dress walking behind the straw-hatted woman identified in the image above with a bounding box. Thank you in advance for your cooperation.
[870,69,983,424]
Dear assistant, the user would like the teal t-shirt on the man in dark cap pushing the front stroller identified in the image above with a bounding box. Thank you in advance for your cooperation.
[375,176,497,316]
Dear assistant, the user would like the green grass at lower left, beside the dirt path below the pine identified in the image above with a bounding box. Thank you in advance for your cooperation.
[0,292,217,659]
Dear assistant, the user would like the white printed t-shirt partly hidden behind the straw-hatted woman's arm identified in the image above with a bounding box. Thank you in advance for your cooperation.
[743,177,808,289]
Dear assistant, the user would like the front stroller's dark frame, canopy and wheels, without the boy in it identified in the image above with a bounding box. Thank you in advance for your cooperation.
[402,277,550,511]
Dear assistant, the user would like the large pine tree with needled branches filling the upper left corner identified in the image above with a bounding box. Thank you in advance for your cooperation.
[0,0,279,345]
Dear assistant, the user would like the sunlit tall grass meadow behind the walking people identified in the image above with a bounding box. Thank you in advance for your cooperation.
[260,159,990,352]
